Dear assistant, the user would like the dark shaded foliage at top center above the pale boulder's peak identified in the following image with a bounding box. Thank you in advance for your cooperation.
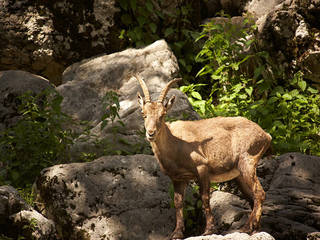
[118,0,198,78]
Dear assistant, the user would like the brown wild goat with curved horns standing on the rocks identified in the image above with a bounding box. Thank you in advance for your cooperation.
[136,76,272,239]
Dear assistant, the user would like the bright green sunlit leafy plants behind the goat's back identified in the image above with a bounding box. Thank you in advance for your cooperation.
[180,14,320,155]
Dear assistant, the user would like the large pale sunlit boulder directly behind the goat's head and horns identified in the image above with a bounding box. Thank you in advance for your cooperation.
[57,40,199,159]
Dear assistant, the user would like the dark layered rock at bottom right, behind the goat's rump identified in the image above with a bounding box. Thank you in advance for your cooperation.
[262,153,320,240]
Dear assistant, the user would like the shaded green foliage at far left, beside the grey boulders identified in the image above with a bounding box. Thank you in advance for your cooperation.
[0,90,73,187]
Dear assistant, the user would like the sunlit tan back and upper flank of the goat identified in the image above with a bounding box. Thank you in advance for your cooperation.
[168,117,271,158]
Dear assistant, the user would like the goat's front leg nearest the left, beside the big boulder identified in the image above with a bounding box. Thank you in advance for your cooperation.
[170,181,187,239]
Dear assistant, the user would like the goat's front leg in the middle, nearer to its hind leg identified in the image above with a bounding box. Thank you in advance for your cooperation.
[197,165,215,235]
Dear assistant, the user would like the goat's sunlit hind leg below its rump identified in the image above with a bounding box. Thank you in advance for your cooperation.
[237,156,266,233]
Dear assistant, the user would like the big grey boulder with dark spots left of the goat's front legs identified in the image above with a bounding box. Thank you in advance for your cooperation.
[36,155,175,240]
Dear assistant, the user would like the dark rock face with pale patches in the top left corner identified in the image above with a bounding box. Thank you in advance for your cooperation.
[0,0,121,84]
